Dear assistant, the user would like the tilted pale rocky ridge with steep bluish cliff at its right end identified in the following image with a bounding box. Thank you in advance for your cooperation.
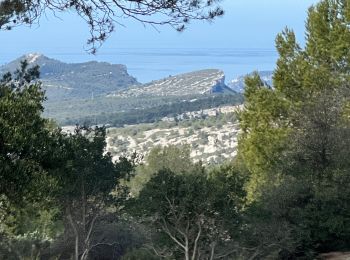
[112,69,233,97]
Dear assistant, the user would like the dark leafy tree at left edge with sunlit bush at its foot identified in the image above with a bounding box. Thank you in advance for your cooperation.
[0,61,62,259]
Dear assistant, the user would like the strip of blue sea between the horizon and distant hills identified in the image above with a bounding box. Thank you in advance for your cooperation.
[3,48,278,83]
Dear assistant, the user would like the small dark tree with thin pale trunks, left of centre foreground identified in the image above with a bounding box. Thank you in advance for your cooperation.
[48,127,133,259]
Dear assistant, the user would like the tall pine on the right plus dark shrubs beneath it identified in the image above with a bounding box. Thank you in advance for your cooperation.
[239,0,350,258]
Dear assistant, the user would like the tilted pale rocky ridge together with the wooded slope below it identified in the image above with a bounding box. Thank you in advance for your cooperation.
[39,66,243,126]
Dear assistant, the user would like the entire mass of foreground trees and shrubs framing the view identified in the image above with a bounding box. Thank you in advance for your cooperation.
[0,0,350,260]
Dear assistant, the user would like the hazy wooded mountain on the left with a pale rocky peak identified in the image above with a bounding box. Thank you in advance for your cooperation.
[0,53,139,100]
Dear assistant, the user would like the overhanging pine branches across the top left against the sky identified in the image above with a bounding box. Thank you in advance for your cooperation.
[0,0,223,53]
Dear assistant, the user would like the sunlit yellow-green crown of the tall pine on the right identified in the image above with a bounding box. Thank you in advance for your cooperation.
[239,0,350,200]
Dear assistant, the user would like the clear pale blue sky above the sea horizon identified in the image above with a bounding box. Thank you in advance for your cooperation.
[0,0,317,63]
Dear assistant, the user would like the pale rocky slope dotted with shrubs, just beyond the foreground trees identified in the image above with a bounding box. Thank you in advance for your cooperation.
[107,106,239,164]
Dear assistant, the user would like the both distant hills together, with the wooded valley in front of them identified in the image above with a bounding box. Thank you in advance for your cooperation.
[0,54,243,126]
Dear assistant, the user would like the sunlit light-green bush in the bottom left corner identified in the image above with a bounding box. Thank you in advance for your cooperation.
[0,203,63,259]
